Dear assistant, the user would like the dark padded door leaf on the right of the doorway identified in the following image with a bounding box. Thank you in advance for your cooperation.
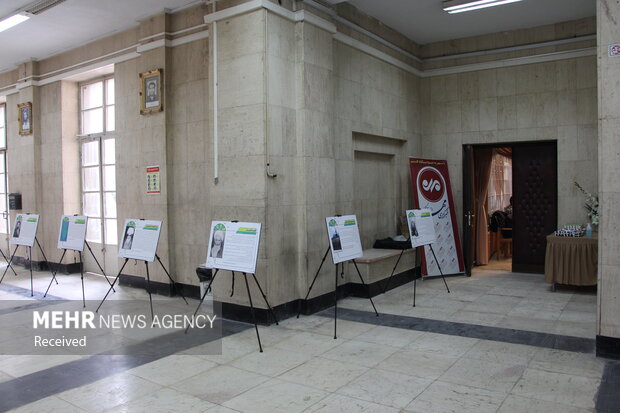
[512,142,558,273]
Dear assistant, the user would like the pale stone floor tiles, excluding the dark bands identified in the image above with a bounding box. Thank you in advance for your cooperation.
[0,262,607,413]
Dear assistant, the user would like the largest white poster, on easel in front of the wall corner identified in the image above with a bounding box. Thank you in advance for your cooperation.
[206,221,261,274]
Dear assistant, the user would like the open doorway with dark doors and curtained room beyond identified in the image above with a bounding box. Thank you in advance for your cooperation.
[463,142,557,274]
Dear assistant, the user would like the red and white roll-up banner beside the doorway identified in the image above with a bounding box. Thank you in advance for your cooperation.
[409,158,465,276]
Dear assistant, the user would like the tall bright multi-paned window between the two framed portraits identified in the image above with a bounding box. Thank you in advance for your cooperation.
[80,78,117,245]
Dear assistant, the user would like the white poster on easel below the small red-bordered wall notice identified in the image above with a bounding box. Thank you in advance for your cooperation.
[118,219,161,262]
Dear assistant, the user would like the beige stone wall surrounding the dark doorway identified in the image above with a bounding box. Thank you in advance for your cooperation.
[422,57,598,233]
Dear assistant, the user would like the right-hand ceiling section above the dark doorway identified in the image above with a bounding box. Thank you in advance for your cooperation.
[344,0,596,44]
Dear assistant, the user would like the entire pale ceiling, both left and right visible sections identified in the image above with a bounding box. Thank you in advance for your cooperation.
[0,0,596,73]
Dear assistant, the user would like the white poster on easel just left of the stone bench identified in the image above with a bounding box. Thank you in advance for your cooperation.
[325,215,364,264]
